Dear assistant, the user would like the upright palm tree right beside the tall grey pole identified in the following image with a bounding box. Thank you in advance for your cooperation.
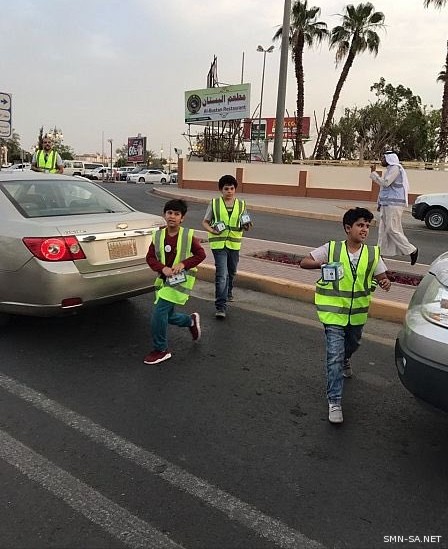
[273,0,328,159]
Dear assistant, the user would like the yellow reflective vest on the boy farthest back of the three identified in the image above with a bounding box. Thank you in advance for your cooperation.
[208,198,246,250]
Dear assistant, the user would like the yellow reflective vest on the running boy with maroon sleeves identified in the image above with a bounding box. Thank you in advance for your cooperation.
[154,227,197,305]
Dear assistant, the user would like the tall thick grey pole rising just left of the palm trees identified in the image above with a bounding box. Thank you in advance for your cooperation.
[273,0,292,164]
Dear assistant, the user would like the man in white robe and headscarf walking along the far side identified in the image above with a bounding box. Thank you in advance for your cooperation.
[370,151,418,265]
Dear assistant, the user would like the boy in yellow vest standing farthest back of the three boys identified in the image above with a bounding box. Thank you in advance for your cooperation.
[202,175,252,319]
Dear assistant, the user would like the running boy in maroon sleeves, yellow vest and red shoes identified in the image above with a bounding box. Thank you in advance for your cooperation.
[143,199,205,364]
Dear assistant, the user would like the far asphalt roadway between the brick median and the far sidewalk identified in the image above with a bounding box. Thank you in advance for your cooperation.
[104,183,448,264]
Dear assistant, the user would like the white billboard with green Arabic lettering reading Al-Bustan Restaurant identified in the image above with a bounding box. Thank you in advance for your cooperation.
[185,84,250,124]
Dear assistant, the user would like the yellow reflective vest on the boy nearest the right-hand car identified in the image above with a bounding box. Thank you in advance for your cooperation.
[314,240,380,326]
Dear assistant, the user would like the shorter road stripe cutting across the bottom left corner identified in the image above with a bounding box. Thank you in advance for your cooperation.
[0,429,182,549]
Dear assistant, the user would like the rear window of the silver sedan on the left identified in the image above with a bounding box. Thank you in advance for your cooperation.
[0,179,133,218]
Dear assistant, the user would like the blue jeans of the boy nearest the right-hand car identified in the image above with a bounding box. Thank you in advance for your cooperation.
[324,324,364,404]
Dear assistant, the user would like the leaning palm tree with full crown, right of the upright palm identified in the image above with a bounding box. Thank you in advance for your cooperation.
[313,2,384,158]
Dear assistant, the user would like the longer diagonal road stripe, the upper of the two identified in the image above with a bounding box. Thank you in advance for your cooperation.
[0,374,324,549]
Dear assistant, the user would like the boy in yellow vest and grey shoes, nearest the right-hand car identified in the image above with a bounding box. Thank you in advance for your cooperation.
[300,208,390,423]
